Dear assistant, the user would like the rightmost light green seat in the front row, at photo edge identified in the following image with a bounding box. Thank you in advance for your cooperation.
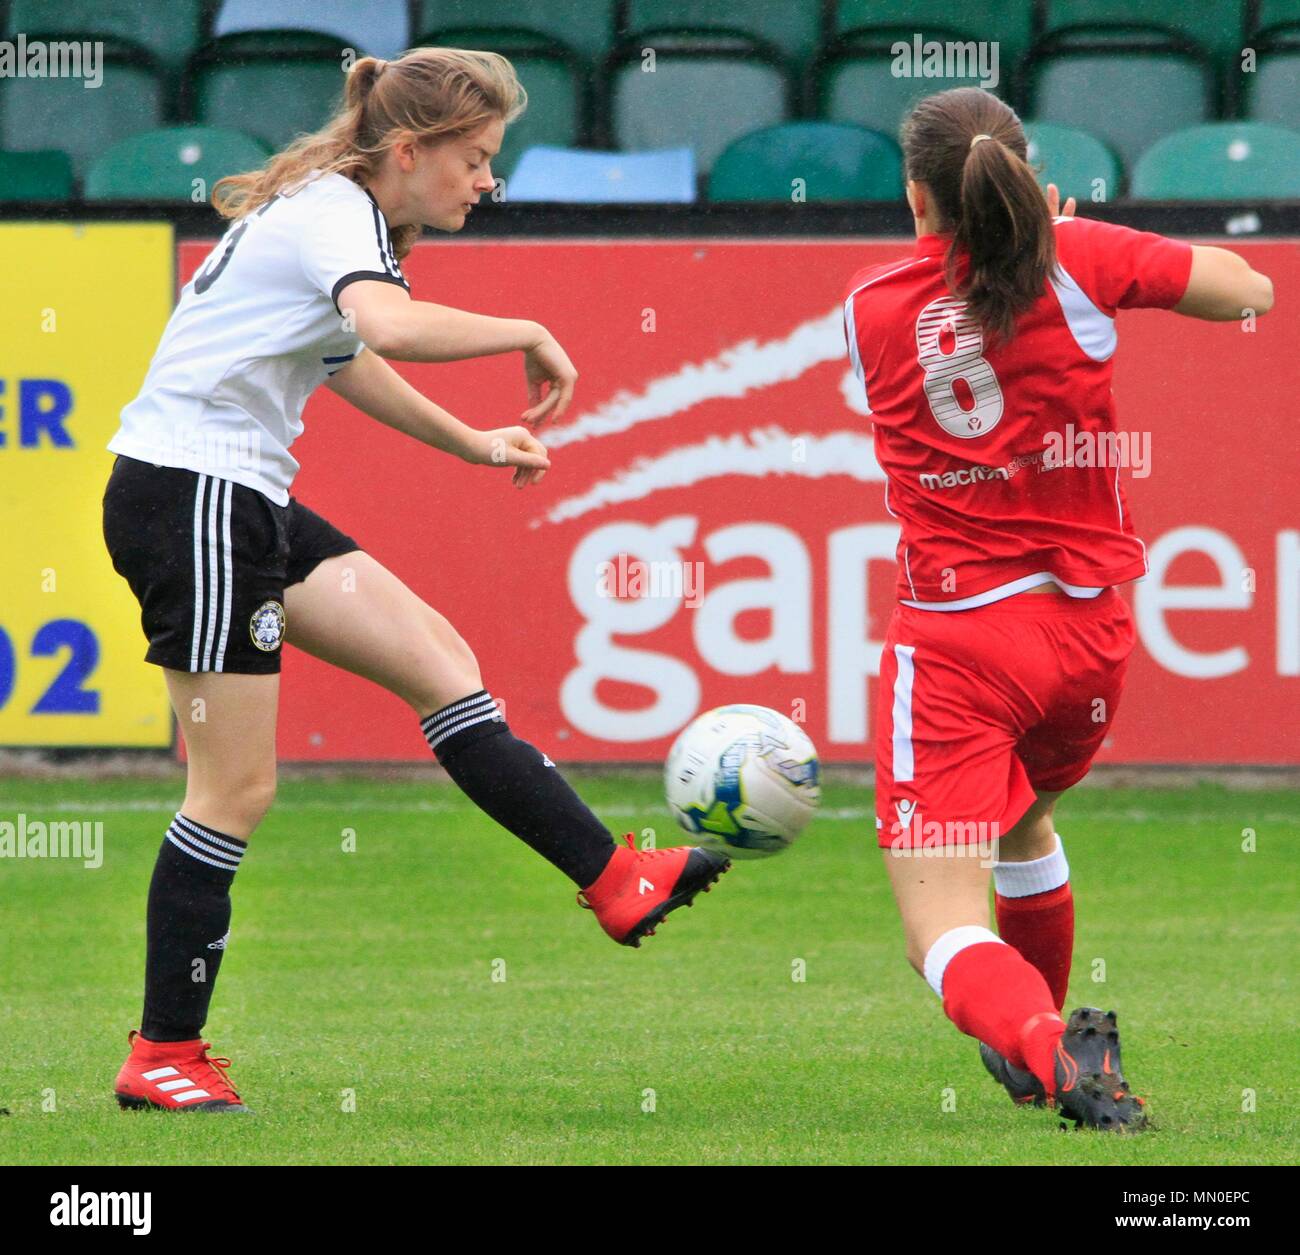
[1132,122,1300,200]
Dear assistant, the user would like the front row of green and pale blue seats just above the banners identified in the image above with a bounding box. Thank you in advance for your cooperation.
[0,122,1300,204]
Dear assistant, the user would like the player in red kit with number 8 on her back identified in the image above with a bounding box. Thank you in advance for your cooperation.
[844,88,1273,1131]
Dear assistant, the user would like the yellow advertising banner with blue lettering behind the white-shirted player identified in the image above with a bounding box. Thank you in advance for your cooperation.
[0,224,173,746]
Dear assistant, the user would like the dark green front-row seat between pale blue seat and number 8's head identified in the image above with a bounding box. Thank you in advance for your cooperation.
[709,122,902,204]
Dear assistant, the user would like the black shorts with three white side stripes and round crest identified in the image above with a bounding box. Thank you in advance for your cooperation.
[104,456,361,675]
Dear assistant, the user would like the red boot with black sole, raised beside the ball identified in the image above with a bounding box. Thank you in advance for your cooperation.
[577,832,731,945]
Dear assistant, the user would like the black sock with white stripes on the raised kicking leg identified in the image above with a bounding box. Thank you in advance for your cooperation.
[420,689,614,888]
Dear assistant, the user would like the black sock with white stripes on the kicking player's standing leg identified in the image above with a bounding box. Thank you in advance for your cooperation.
[140,813,247,1042]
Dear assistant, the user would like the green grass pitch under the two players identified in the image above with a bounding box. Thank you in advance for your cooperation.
[0,771,1300,1164]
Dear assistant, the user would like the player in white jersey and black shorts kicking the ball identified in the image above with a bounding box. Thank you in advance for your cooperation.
[104,48,727,1111]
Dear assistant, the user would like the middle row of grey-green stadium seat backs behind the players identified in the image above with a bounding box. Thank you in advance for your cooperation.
[0,31,1300,187]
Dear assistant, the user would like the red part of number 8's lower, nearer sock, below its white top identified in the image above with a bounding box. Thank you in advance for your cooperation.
[943,942,1065,1094]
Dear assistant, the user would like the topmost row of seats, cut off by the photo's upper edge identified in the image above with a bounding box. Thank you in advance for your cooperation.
[0,0,1300,73]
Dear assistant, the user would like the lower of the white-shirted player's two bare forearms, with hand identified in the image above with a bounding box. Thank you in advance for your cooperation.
[326,349,551,488]
